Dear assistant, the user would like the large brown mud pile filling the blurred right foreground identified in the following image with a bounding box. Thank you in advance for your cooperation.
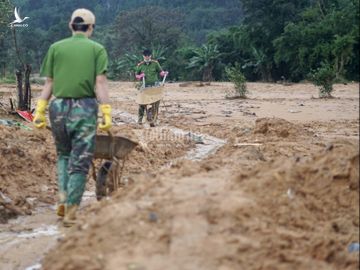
[43,135,359,270]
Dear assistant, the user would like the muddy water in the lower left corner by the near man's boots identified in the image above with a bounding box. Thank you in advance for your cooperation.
[0,191,96,270]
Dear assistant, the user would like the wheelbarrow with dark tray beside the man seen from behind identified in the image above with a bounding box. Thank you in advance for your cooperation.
[92,132,138,200]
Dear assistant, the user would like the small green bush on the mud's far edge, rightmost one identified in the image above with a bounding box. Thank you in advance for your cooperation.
[310,64,336,98]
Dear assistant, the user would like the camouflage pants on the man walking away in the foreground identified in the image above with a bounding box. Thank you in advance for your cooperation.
[49,98,98,205]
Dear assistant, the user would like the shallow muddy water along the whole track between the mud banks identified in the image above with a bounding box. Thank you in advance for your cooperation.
[0,111,225,270]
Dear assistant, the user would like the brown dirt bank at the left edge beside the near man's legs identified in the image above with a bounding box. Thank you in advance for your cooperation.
[0,126,56,222]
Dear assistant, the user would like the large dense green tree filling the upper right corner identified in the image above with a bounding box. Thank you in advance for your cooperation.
[274,0,359,80]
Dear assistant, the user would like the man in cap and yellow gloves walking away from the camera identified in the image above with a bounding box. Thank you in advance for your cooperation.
[34,9,111,226]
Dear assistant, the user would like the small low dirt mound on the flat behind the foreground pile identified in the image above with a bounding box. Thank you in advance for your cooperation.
[254,118,310,138]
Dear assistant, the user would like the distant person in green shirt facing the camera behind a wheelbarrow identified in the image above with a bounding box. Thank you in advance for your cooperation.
[135,50,168,127]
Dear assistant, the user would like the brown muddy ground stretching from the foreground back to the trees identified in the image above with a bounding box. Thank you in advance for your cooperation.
[0,83,359,270]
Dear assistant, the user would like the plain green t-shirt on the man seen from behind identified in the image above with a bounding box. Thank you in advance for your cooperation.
[40,34,108,98]
